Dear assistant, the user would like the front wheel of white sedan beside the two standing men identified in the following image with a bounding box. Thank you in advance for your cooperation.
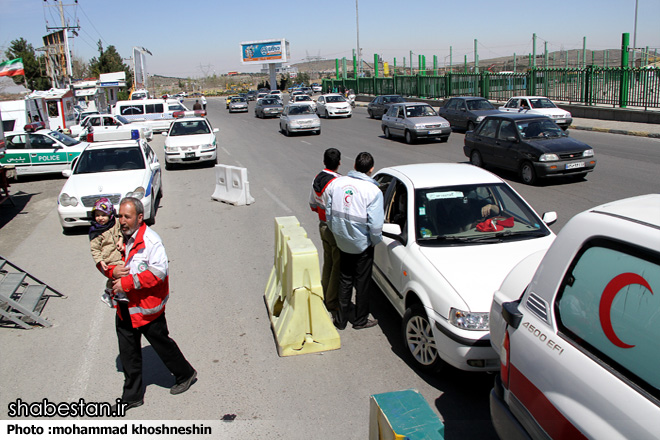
[401,304,444,373]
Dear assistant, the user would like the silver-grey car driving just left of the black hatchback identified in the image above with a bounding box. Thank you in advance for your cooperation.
[381,102,451,144]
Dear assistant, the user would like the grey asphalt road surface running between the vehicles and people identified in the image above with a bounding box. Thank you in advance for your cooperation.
[0,98,660,440]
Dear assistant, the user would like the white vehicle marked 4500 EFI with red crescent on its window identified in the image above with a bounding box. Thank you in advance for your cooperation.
[490,194,660,440]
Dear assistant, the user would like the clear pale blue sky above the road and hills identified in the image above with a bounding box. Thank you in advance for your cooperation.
[0,0,660,78]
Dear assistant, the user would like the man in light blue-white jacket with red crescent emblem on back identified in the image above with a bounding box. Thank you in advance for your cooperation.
[325,152,384,330]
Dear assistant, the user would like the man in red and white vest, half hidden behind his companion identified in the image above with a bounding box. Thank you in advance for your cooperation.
[309,148,341,316]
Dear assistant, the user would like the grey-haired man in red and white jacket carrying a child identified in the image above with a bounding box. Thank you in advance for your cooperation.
[106,197,197,410]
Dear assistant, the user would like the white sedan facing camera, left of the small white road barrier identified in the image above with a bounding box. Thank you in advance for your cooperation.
[163,118,218,170]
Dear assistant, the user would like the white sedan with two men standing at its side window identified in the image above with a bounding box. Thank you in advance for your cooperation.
[372,163,557,372]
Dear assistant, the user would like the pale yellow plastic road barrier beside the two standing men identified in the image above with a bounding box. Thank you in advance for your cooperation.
[264,217,341,356]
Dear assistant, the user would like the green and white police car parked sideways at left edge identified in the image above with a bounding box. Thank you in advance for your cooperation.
[0,122,89,175]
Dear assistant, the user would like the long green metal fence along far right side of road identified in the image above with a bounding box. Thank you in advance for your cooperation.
[323,66,660,108]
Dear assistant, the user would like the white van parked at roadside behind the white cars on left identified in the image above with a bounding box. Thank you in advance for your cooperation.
[112,99,188,131]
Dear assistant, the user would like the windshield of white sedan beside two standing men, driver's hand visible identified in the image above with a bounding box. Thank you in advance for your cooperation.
[415,183,550,246]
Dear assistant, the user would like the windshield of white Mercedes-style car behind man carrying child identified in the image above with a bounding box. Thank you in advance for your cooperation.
[73,146,144,174]
